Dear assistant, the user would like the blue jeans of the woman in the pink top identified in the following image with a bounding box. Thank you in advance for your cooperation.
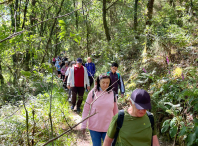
[89,130,107,146]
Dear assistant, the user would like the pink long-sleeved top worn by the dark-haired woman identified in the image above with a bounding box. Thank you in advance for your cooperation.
[81,89,118,132]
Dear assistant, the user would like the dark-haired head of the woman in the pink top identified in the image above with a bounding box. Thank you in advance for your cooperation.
[96,73,112,91]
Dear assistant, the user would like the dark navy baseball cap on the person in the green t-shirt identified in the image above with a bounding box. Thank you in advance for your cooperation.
[131,89,151,109]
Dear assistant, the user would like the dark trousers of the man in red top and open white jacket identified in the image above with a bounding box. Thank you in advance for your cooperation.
[71,87,85,108]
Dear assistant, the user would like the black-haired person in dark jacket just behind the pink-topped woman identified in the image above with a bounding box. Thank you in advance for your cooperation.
[108,62,125,98]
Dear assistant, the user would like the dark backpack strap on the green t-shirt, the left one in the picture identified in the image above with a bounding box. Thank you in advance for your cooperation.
[111,110,124,146]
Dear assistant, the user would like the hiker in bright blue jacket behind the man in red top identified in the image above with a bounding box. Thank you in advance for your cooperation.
[85,57,96,87]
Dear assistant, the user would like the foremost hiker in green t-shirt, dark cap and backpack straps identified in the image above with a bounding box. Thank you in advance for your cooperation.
[103,89,159,146]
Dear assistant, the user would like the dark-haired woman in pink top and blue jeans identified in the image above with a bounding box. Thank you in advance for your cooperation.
[81,73,118,146]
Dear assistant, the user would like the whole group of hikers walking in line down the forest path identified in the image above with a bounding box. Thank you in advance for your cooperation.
[51,57,159,146]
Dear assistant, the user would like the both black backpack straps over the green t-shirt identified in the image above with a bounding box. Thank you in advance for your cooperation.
[111,110,154,146]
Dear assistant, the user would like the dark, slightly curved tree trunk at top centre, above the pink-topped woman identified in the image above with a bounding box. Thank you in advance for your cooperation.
[102,0,111,42]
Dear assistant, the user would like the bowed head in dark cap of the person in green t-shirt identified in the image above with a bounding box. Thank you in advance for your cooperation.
[130,89,151,117]
